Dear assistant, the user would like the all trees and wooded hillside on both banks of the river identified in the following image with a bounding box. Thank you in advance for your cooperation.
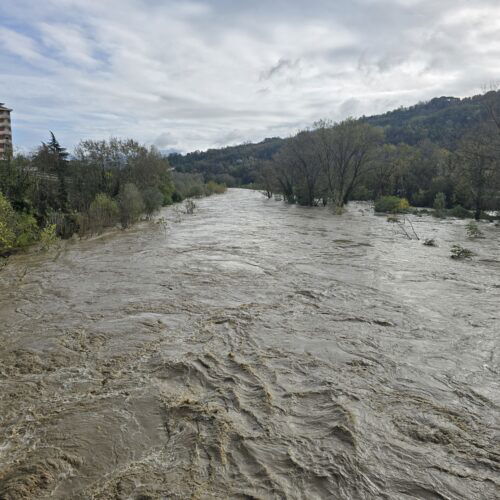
[0,92,500,248]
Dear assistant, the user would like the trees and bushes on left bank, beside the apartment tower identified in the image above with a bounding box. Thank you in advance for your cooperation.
[0,134,226,255]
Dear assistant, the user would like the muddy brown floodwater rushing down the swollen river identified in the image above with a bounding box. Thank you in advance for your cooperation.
[0,190,500,500]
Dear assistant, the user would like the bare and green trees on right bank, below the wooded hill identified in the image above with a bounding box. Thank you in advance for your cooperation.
[256,93,500,219]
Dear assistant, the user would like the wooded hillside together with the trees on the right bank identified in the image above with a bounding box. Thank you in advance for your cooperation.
[169,91,500,218]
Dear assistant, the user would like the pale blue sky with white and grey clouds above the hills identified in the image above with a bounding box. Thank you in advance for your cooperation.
[0,0,500,151]
